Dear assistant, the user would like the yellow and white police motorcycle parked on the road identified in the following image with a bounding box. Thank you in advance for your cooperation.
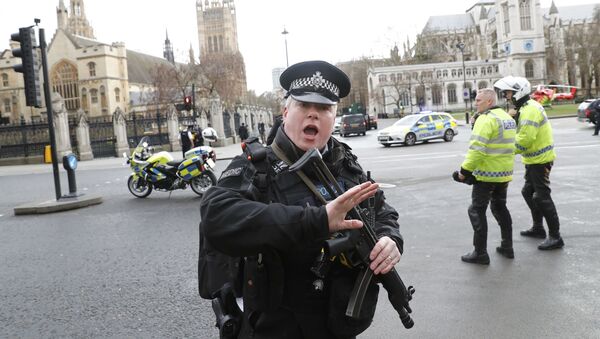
[123,128,217,198]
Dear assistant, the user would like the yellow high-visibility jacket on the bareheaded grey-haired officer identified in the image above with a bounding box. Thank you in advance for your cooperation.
[461,107,517,182]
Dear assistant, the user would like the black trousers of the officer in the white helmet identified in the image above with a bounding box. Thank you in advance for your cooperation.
[521,162,560,237]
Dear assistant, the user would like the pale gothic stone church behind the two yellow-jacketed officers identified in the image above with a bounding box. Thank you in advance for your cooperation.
[367,0,598,113]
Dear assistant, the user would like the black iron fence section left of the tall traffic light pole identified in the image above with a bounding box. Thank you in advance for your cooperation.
[0,119,50,158]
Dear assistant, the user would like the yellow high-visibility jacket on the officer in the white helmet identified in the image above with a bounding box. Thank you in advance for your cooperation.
[515,99,556,165]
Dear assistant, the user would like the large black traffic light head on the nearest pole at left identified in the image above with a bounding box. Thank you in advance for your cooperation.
[10,27,42,107]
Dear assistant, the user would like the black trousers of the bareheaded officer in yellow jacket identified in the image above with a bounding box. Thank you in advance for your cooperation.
[468,181,512,252]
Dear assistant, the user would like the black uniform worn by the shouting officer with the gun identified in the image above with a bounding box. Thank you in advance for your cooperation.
[200,128,403,338]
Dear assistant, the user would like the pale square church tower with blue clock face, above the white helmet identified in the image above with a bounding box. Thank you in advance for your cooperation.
[495,0,547,85]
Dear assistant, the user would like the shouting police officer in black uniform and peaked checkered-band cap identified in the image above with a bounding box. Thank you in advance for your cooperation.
[200,61,403,338]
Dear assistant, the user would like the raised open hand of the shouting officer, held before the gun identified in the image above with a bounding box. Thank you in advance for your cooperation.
[325,182,379,233]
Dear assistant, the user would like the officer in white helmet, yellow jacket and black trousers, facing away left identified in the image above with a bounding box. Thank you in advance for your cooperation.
[494,76,564,250]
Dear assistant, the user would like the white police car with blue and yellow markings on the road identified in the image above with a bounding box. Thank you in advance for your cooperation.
[377,111,458,147]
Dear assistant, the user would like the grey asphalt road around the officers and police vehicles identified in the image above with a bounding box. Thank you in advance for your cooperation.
[0,118,600,338]
